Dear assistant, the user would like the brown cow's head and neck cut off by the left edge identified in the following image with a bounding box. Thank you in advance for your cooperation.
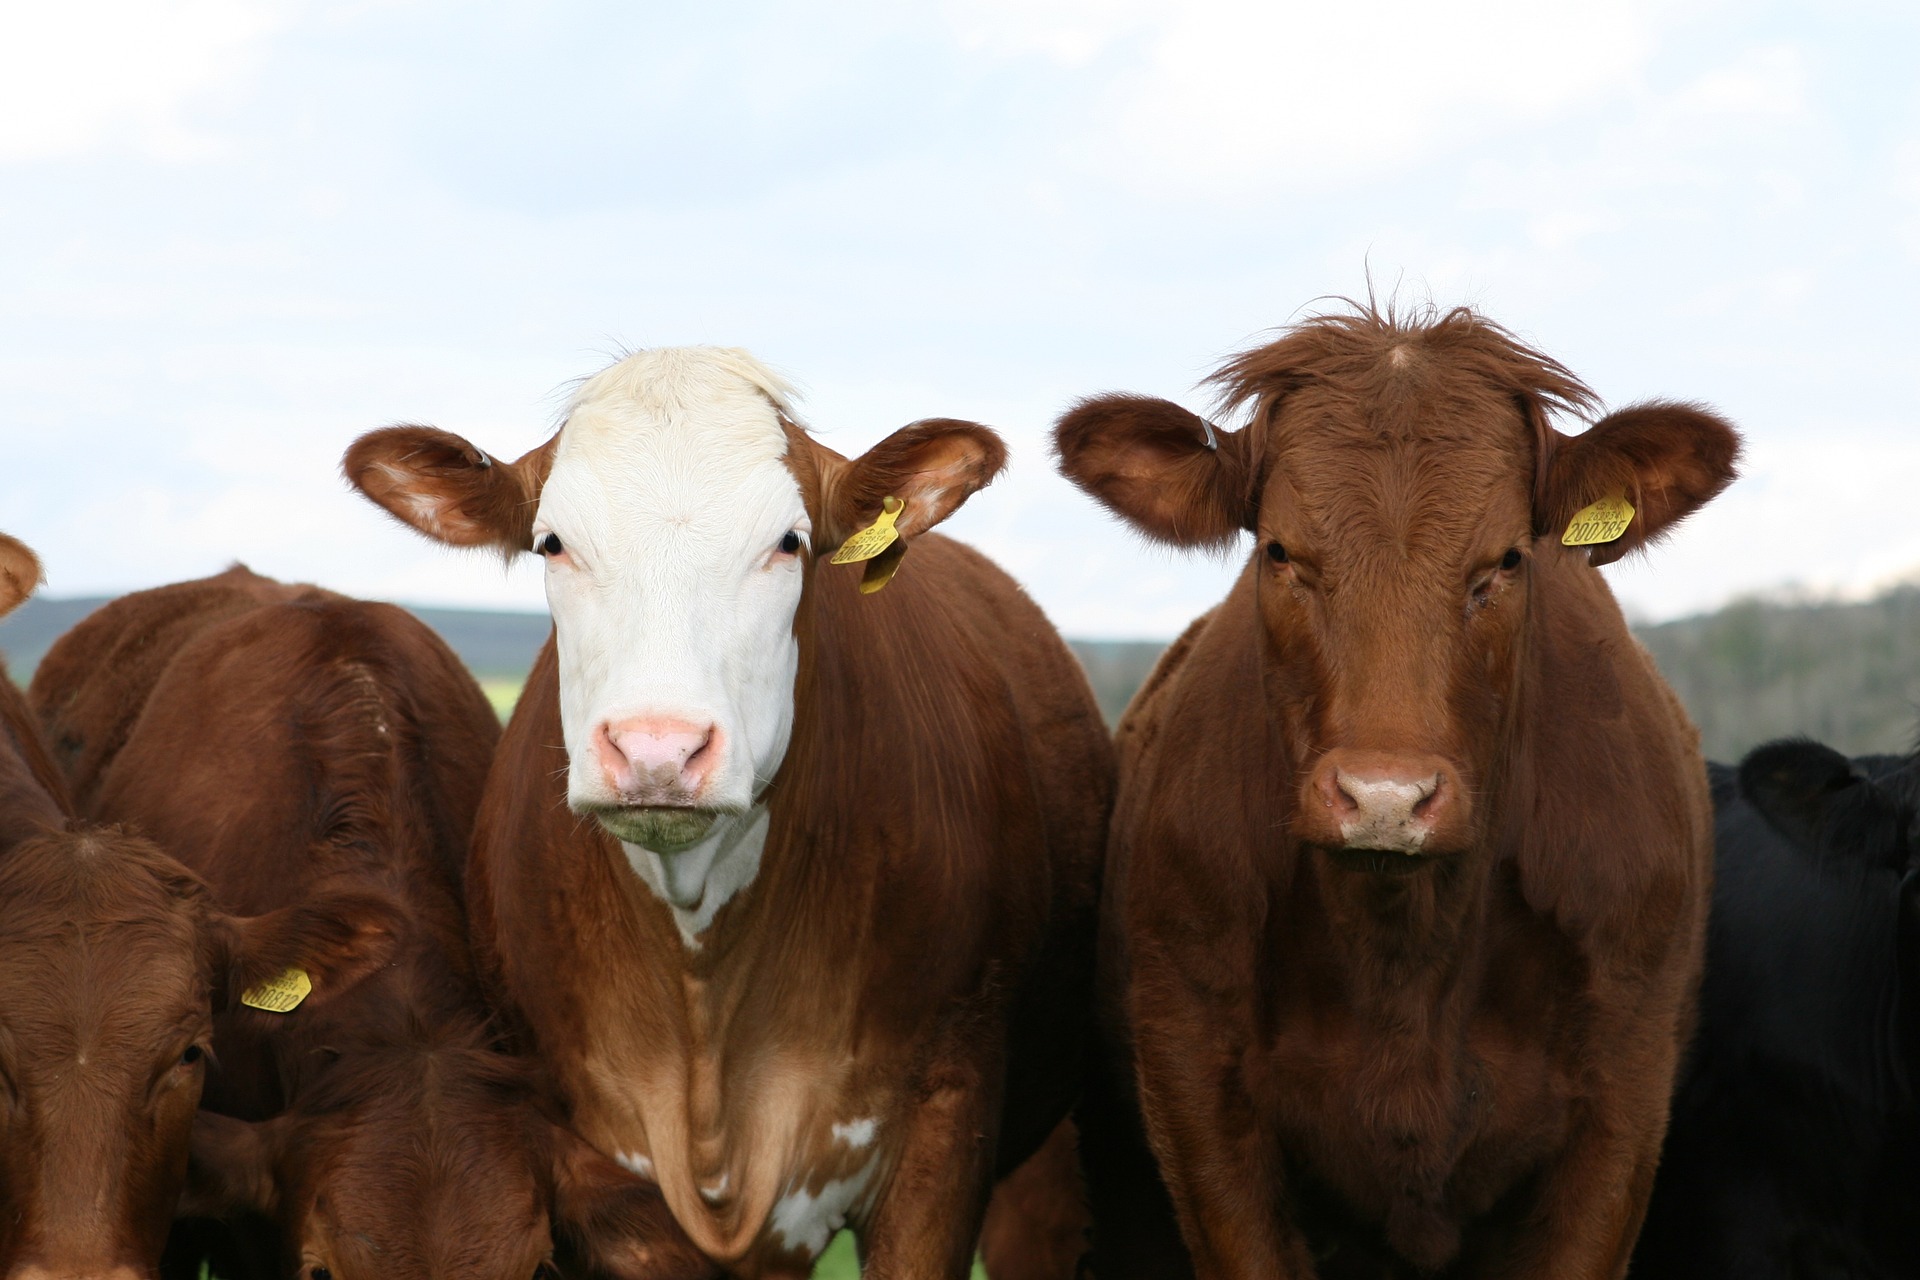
[0,535,396,1280]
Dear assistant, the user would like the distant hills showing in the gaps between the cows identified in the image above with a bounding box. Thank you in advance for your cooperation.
[0,587,1920,760]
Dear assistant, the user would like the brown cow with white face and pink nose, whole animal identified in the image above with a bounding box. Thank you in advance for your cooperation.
[346,347,1112,1276]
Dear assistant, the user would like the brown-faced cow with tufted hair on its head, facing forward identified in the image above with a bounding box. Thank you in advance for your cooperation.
[1056,307,1740,1280]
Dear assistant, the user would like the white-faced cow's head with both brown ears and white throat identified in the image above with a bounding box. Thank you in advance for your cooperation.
[342,347,1006,944]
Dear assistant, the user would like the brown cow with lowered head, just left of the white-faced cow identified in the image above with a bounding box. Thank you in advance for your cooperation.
[33,568,708,1280]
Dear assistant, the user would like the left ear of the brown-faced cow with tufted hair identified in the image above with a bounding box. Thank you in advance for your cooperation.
[1054,395,1258,547]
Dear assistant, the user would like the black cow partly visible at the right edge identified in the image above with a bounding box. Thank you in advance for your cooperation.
[1632,739,1920,1280]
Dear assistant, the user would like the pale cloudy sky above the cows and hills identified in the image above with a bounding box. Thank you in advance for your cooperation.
[0,0,1920,635]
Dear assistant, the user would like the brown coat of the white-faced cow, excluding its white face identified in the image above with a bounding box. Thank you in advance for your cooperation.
[348,420,1112,1276]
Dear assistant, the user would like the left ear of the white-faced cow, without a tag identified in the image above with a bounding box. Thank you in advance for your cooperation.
[340,426,559,557]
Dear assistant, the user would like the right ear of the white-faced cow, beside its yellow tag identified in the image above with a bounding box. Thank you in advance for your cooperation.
[814,418,1006,555]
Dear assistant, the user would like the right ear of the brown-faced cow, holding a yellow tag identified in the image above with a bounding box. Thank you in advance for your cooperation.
[1536,401,1740,564]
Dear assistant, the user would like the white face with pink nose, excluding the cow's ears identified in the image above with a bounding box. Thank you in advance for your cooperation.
[532,347,812,854]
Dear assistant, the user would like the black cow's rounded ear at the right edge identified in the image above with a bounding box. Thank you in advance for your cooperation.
[1740,739,1912,869]
